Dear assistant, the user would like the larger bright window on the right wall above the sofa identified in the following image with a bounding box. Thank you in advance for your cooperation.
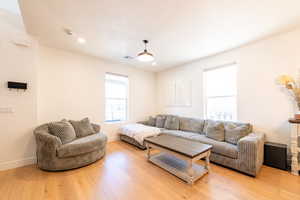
[204,64,237,121]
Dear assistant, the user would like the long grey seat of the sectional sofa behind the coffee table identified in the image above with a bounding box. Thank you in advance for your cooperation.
[162,130,238,159]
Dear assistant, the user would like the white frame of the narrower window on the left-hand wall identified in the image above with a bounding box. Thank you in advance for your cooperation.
[104,72,129,123]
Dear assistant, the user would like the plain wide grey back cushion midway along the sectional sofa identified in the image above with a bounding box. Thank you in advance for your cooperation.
[179,117,204,133]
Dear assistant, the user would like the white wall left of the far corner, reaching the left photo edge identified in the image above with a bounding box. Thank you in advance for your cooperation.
[0,9,156,170]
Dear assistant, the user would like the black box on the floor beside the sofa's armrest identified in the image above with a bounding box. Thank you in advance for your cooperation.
[264,142,288,170]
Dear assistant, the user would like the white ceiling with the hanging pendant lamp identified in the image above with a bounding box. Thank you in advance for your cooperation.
[20,0,300,71]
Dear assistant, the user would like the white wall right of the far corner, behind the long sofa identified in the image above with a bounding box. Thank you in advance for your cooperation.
[157,29,300,143]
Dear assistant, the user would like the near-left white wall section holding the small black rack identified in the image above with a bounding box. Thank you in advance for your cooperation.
[0,9,37,170]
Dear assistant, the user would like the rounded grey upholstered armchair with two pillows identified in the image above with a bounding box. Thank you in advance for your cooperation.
[34,120,107,171]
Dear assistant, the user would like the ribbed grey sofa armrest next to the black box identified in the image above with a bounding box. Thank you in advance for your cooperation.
[237,133,265,176]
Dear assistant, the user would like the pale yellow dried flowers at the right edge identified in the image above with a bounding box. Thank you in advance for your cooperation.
[277,75,300,120]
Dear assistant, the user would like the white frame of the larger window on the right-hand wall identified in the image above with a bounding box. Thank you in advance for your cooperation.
[202,62,239,122]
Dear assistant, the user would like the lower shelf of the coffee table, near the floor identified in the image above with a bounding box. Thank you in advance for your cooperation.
[148,152,208,184]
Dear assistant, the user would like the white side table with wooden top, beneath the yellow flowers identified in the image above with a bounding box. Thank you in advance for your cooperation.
[289,119,300,176]
